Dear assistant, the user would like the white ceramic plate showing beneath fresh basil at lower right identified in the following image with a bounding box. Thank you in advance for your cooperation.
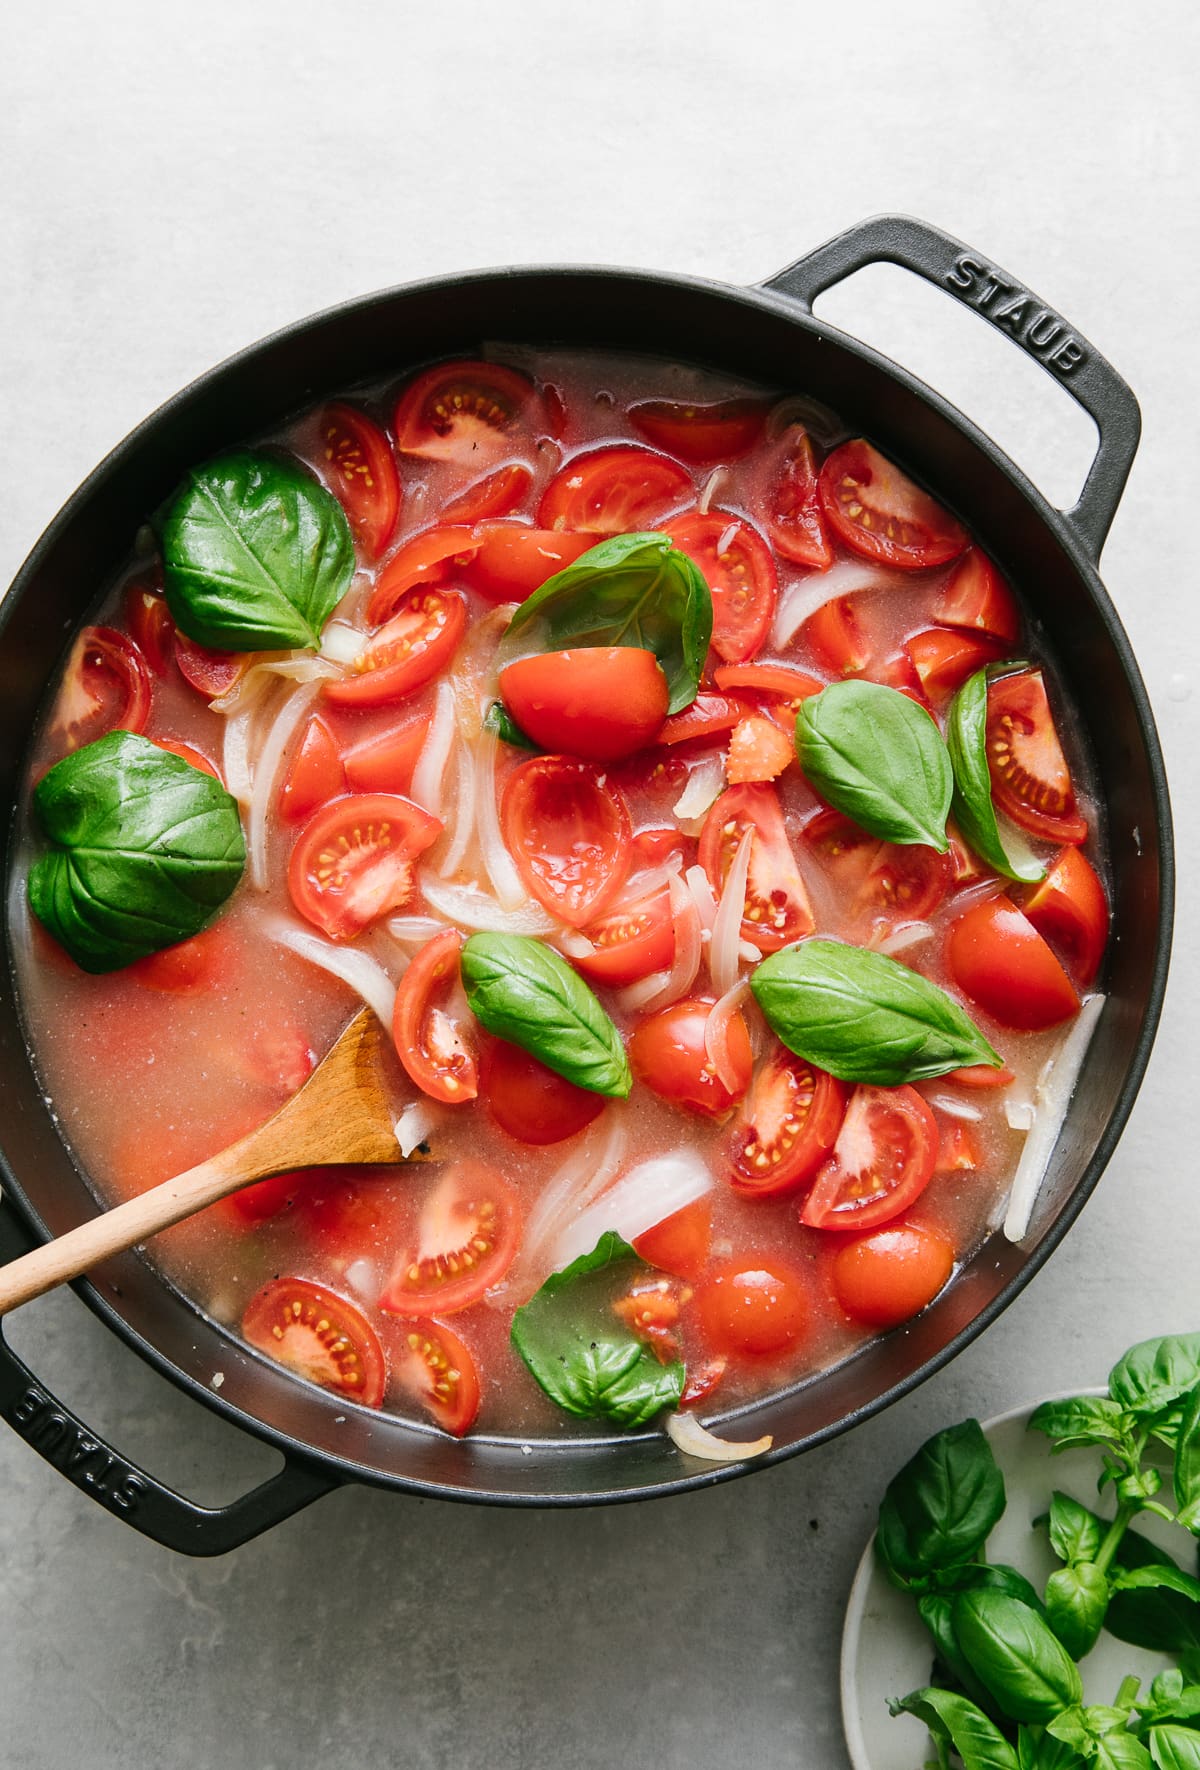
[841,1389,1179,1770]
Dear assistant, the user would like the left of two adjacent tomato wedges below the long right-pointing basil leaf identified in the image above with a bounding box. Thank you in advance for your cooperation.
[729,1046,846,1198]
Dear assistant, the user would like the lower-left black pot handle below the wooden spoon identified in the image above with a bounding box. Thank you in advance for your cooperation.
[0,1202,338,1556]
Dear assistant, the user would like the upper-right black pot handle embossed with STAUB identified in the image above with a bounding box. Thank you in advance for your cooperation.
[759,216,1142,561]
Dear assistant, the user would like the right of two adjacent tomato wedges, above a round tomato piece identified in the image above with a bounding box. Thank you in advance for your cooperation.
[800,1085,938,1230]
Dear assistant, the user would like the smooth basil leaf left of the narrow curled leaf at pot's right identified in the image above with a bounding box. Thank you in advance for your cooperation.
[796,681,954,853]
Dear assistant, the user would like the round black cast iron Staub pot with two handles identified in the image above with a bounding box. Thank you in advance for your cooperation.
[0,216,1172,1554]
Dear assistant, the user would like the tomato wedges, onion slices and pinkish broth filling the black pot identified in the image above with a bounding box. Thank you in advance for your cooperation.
[11,347,1106,1437]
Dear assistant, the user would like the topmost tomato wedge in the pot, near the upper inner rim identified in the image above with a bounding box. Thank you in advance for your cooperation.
[393,363,545,462]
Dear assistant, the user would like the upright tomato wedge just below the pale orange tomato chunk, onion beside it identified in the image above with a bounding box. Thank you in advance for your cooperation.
[699,782,816,952]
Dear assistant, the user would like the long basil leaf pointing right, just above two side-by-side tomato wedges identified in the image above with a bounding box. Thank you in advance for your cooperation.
[750,940,1002,1087]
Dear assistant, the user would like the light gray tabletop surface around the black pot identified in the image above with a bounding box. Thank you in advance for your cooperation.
[0,0,1200,1770]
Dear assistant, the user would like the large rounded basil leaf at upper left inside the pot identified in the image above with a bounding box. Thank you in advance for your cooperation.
[163,450,354,651]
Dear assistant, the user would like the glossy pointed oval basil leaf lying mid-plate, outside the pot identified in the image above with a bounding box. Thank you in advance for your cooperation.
[954,1589,1083,1722]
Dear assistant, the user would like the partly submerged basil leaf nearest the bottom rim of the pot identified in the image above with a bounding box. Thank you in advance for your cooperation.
[512,1230,687,1427]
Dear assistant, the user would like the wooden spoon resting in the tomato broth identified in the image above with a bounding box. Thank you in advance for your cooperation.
[0,1009,423,1315]
